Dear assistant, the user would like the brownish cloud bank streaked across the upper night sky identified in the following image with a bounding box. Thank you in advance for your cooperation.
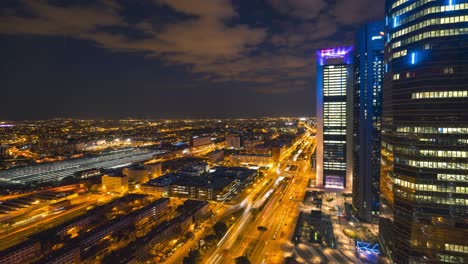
[0,0,383,101]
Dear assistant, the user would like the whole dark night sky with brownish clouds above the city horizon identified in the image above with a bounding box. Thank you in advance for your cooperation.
[0,0,384,120]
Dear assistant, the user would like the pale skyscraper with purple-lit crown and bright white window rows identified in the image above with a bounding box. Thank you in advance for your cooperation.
[316,47,352,189]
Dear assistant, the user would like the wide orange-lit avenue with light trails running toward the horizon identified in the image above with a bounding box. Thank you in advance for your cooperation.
[204,136,315,264]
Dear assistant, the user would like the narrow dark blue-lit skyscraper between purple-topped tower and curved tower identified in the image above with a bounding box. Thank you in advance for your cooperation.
[353,21,385,222]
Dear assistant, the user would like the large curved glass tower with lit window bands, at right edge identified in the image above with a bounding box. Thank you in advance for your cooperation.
[379,0,468,264]
